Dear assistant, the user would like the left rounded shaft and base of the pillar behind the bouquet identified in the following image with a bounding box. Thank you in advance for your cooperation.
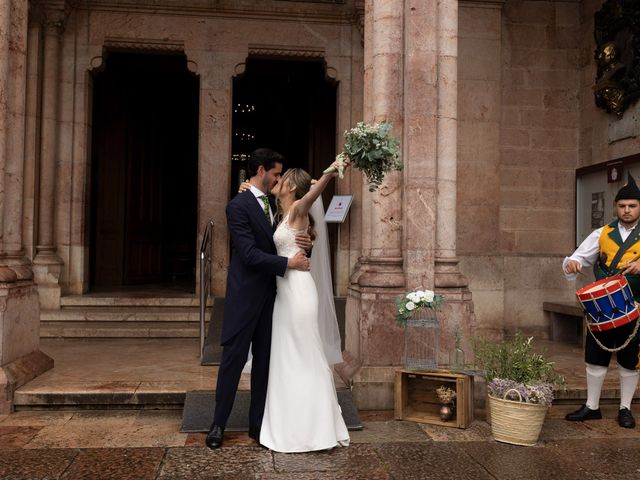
[346,0,405,408]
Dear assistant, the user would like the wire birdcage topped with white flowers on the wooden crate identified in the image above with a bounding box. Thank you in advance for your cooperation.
[396,290,444,369]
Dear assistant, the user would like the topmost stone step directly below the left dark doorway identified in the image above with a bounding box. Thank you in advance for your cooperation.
[60,294,213,307]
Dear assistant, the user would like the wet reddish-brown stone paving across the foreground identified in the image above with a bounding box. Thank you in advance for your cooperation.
[0,406,640,480]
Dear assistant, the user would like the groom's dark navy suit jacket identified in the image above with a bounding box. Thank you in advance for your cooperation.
[221,190,287,344]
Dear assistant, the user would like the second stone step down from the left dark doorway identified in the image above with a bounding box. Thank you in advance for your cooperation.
[40,306,206,322]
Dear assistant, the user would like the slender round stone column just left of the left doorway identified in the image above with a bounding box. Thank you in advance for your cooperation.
[33,11,64,308]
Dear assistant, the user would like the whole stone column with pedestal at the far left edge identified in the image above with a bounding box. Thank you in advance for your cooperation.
[0,0,53,414]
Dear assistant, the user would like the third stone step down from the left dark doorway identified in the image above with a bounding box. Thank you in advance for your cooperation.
[40,321,200,338]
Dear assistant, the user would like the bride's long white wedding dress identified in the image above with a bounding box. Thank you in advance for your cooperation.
[260,217,349,452]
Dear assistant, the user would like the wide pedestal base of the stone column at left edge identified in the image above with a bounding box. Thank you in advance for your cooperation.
[0,281,53,413]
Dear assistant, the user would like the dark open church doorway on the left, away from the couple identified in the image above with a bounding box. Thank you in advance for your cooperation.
[90,52,199,291]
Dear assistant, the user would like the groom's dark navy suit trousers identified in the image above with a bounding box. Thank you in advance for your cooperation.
[213,296,275,429]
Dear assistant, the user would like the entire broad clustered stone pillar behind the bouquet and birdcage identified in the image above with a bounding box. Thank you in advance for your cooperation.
[347,0,473,408]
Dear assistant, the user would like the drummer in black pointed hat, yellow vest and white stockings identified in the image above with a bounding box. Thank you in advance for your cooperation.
[562,174,640,428]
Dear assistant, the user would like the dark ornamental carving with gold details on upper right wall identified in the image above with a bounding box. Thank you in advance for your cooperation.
[593,0,640,117]
